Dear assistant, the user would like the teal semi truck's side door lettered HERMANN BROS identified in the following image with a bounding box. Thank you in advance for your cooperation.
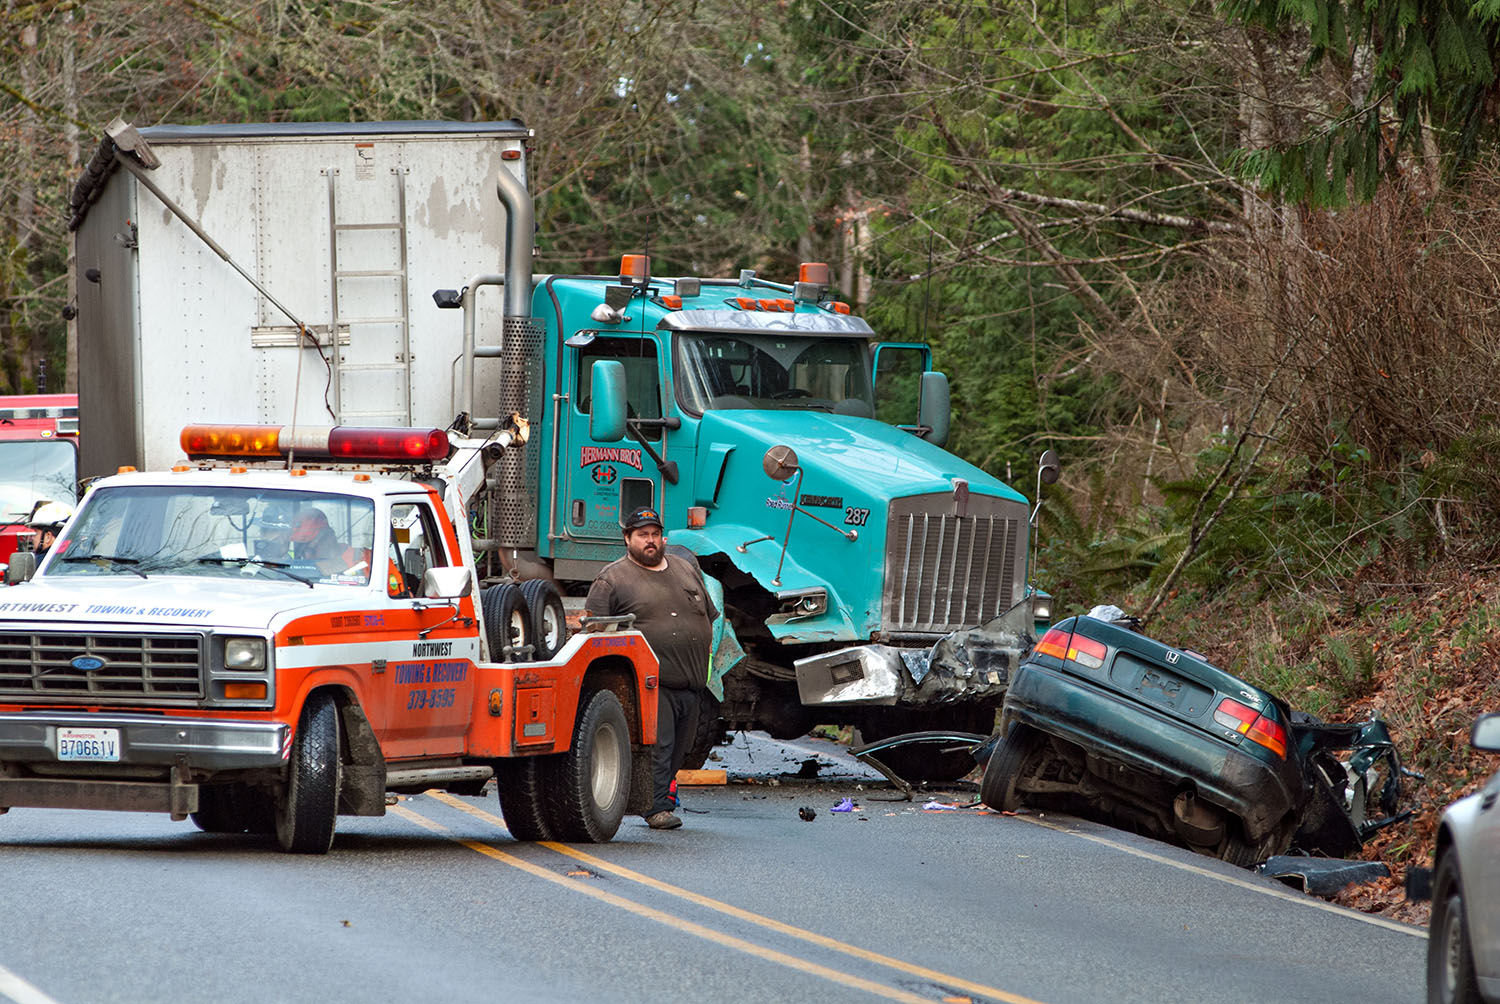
[554,335,665,561]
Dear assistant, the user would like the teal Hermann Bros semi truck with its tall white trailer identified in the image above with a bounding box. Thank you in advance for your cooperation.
[74,115,1055,780]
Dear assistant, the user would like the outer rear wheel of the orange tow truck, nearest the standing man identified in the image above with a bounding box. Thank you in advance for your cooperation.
[548,690,630,843]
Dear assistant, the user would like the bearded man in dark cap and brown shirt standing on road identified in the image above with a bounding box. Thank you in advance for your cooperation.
[584,507,719,830]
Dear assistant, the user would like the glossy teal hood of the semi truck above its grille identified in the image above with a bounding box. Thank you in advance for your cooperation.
[698,410,1026,503]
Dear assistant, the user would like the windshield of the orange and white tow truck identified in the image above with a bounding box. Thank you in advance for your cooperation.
[42,485,375,587]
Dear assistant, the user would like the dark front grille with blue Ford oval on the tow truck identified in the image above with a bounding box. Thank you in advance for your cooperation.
[0,632,203,702]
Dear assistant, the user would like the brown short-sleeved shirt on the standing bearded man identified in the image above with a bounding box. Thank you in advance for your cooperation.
[584,554,719,690]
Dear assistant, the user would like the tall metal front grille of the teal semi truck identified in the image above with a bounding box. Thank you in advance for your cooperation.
[881,494,1026,635]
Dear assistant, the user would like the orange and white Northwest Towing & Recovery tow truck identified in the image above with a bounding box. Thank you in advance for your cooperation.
[0,426,657,854]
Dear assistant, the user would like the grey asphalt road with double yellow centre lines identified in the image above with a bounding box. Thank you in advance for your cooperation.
[0,737,1427,1004]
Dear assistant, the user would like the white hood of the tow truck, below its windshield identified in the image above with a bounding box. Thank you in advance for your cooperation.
[0,572,353,630]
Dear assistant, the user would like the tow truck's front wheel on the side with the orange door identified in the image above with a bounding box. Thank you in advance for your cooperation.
[276,693,344,854]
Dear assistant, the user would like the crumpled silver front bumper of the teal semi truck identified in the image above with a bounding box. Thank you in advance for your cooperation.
[795,602,1037,705]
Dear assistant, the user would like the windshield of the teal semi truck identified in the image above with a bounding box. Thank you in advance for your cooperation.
[677,333,875,419]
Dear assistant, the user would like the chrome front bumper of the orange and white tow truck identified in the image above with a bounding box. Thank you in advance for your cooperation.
[0,711,291,819]
